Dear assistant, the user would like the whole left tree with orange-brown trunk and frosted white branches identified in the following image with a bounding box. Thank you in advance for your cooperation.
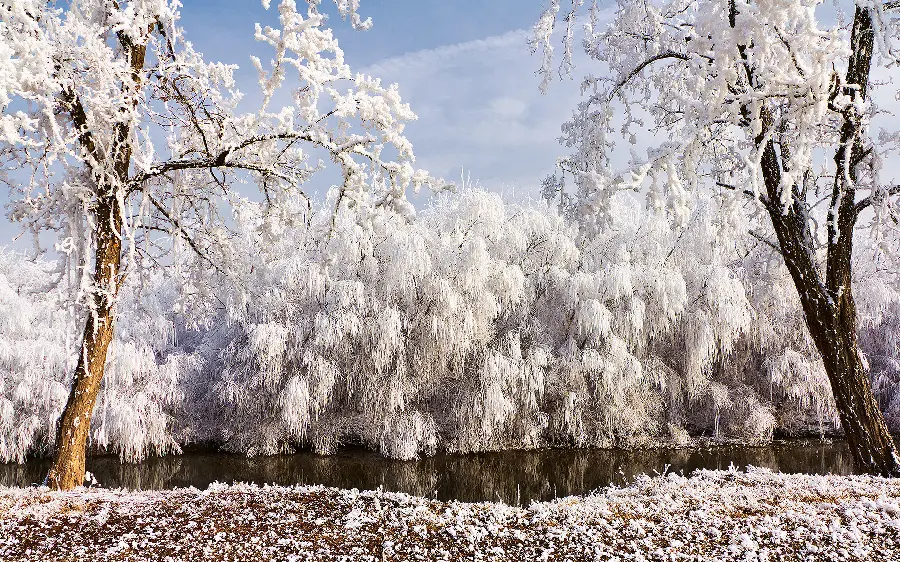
[0,0,431,489]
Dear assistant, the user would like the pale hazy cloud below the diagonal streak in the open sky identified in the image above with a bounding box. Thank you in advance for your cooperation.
[362,30,589,201]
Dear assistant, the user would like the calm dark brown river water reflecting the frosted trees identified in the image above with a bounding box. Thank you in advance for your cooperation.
[0,440,853,504]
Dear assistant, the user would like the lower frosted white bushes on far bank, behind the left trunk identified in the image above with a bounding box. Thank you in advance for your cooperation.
[0,251,186,462]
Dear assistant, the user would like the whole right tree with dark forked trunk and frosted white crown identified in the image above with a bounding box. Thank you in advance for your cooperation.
[534,0,900,476]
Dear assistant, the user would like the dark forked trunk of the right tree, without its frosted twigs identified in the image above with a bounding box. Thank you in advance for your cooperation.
[752,4,900,476]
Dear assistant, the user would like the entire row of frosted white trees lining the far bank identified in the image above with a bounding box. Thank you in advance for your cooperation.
[0,190,900,462]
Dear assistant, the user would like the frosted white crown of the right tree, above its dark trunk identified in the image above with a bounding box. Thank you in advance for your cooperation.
[532,0,900,238]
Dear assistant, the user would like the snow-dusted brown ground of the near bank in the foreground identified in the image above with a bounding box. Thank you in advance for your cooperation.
[0,469,900,561]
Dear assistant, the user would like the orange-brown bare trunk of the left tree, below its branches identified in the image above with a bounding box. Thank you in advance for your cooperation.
[46,197,122,490]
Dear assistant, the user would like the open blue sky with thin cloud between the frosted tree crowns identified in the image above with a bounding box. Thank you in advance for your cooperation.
[0,0,579,248]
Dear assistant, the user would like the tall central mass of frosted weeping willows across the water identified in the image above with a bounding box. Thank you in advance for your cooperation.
[171,187,892,458]
